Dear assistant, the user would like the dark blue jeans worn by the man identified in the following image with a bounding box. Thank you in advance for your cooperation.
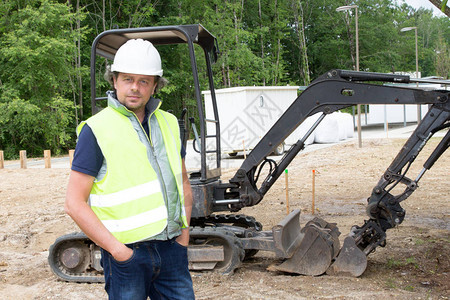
[101,239,195,300]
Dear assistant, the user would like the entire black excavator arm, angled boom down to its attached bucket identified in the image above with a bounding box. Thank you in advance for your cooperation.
[216,70,450,276]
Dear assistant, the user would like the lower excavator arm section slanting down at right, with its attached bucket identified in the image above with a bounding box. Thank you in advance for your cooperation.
[327,111,450,276]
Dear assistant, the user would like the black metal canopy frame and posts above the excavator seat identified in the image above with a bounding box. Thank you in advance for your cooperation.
[90,24,221,182]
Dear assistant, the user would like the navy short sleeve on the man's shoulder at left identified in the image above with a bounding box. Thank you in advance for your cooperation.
[72,124,104,177]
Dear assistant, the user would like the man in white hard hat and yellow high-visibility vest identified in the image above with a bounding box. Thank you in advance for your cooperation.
[65,39,194,299]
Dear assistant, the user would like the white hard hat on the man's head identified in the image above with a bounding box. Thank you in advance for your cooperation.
[111,39,163,76]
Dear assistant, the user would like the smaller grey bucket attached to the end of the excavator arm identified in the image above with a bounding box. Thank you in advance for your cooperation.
[327,236,367,277]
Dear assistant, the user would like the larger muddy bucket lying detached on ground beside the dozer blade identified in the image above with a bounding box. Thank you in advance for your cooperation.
[270,211,340,276]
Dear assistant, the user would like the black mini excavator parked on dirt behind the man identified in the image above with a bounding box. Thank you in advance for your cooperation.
[48,24,450,282]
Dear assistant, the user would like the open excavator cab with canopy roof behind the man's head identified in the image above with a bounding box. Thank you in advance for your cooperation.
[91,24,221,182]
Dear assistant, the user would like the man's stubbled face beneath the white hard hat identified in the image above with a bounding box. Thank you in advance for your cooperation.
[114,73,156,112]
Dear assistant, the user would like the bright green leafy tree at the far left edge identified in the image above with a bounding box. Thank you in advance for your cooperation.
[0,0,85,157]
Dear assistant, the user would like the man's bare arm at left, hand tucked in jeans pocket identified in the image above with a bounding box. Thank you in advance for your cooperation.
[64,170,133,261]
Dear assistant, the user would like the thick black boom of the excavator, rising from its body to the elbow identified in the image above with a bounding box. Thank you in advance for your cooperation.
[230,70,449,211]
